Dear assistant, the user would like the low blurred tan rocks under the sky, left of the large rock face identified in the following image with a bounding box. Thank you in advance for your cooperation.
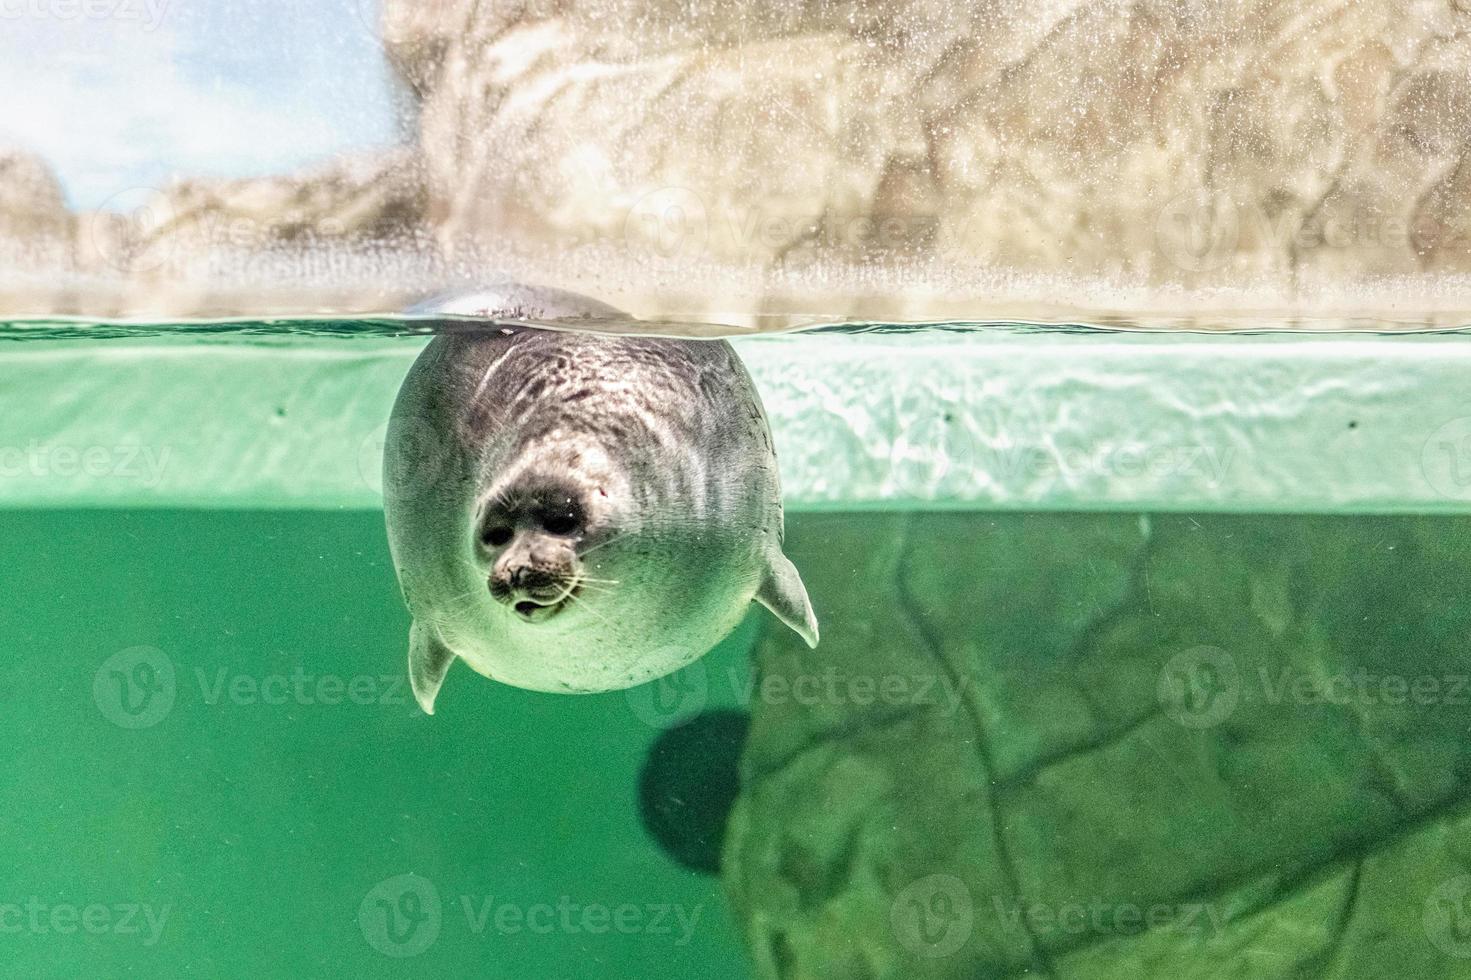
[17,150,443,316]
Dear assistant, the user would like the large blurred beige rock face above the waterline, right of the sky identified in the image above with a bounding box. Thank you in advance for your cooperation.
[385,0,1471,328]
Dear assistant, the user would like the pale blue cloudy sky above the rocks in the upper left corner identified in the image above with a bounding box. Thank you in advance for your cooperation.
[0,0,399,209]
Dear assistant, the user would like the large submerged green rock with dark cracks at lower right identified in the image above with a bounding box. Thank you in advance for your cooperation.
[722,515,1471,980]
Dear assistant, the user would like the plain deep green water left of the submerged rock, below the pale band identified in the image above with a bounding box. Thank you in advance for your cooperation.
[0,511,749,980]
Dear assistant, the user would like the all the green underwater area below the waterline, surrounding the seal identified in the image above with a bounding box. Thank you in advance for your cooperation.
[0,321,1471,980]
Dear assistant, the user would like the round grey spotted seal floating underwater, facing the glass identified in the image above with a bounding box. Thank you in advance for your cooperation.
[384,285,818,714]
